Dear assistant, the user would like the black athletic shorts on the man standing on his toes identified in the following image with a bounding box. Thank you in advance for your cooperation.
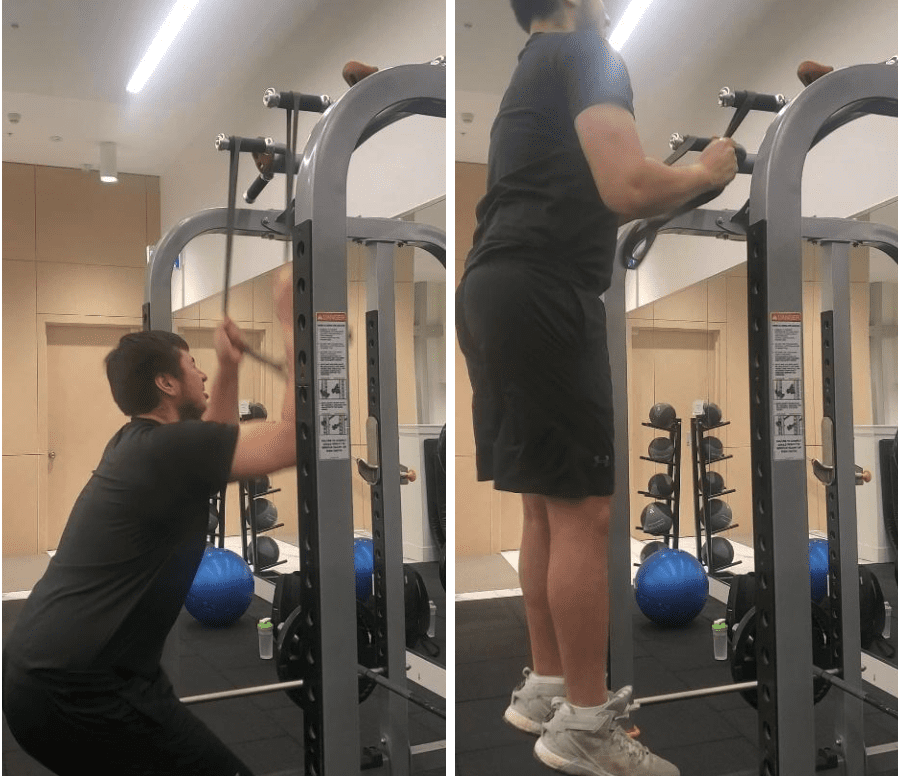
[456,259,614,498]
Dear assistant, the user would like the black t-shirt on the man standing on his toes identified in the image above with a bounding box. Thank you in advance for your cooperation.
[467,31,633,293]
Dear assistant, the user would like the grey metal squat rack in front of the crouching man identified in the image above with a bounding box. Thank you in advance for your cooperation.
[143,58,446,776]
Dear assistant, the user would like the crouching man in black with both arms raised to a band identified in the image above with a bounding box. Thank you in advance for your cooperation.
[3,273,296,776]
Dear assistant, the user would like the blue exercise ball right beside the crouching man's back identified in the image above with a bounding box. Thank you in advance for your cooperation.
[184,547,255,628]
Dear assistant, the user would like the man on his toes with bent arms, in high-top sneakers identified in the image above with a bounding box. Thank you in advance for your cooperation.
[456,0,736,776]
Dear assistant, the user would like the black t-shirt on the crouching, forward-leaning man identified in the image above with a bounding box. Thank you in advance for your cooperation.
[5,418,238,681]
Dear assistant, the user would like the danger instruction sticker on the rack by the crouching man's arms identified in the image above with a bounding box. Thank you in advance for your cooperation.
[315,313,349,461]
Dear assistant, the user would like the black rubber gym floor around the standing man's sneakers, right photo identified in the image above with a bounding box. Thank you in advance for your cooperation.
[455,564,898,776]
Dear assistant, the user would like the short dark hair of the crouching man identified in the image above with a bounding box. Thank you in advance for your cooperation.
[105,331,190,417]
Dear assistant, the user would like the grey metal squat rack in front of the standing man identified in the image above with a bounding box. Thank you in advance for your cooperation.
[606,60,898,776]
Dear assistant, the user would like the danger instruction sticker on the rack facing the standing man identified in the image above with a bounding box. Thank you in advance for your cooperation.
[770,313,805,461]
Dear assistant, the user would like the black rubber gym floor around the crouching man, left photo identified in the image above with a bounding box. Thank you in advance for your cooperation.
[3,563,446,776]
